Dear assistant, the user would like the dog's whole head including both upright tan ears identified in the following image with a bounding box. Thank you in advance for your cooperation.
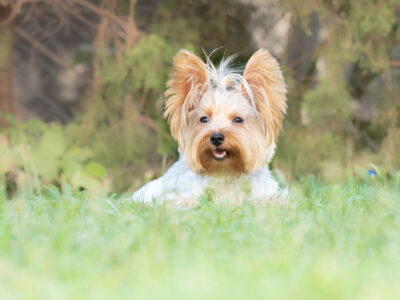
[165,50,286,177]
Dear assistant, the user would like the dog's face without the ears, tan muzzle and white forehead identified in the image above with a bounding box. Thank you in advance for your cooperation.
[183,90,267,176]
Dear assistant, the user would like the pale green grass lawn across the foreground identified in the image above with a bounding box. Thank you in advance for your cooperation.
[0,180,400,299]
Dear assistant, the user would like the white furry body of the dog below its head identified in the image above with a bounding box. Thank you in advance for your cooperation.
[132,150,280,204]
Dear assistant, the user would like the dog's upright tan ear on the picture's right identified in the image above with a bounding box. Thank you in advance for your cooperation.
[243,49,286,144]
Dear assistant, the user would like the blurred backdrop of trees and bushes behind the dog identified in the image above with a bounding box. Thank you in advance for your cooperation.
[0,0,400,198]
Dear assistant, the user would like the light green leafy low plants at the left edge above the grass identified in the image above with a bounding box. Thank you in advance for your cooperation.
[0,120,109,197]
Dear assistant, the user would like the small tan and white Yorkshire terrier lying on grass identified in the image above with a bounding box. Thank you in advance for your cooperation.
[132,49,287,205]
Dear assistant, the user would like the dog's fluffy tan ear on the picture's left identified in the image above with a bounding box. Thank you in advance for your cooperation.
[164,50,208,147]
